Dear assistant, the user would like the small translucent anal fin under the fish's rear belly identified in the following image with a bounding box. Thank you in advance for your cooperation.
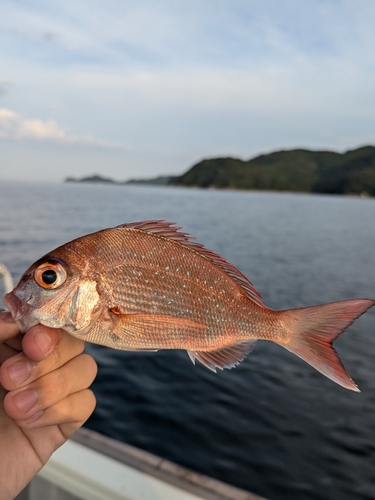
[187,340,256,372]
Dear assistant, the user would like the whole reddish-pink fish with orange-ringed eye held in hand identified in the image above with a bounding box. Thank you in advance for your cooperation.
[4,220,375,392]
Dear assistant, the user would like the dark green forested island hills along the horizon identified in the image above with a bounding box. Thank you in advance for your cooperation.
[66,146,375,196]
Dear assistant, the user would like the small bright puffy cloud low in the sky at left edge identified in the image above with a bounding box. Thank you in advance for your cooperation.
[0,109,130,150]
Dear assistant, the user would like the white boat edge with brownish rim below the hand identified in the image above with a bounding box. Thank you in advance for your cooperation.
[17,428,265,500]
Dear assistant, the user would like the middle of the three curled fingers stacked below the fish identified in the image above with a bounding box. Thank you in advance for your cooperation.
[4,354,97,420]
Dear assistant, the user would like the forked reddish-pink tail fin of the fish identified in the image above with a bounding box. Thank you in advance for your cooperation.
[280,299,375,392]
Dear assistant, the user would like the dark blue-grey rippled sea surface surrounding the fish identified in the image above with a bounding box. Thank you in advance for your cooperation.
[0,182,375,500]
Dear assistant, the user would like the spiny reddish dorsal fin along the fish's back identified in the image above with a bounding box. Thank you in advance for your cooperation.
[116,220,266,307]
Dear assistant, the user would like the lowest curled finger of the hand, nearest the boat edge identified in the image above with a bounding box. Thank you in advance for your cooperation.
[16,389,96,439]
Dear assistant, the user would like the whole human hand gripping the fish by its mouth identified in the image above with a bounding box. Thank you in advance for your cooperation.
[0,311,97,500]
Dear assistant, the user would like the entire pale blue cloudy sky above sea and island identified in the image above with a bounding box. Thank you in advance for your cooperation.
[0,0,375,182]
